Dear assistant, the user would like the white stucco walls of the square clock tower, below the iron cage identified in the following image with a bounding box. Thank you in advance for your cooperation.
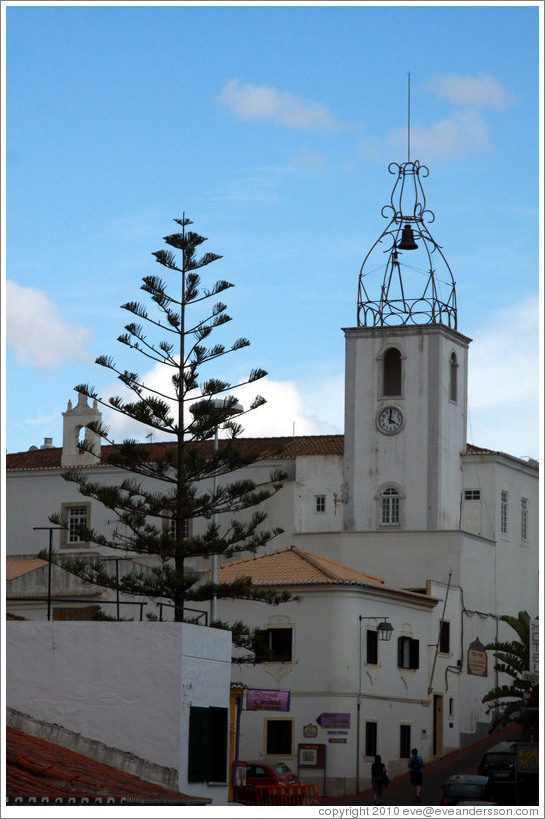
[344,326,469,531]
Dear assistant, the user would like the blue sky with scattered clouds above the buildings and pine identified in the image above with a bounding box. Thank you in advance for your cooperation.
[2,3,542,457]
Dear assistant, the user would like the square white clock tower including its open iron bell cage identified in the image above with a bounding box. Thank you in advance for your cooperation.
[343,161,470,532]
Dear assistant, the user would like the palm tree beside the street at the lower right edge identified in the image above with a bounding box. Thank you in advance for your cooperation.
[483,611,539,741]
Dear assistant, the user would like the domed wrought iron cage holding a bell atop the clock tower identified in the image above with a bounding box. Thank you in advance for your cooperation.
[357,160,457,330]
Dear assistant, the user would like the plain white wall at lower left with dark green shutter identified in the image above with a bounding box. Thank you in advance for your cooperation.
[6,621,231,804]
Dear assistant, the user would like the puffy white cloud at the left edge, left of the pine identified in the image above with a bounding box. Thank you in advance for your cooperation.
[6,281,92,370]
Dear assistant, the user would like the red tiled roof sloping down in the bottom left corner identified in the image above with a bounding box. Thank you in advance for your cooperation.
[6,726,211,805]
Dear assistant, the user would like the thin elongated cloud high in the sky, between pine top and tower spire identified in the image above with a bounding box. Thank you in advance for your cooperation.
[218,80,339,131]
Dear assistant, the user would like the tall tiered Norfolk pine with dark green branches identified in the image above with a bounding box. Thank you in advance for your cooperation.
[50,216,291,636]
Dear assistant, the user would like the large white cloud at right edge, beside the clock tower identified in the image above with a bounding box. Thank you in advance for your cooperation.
[468,298,540,458]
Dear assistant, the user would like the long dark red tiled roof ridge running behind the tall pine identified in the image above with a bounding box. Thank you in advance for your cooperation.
[6,435,344,470]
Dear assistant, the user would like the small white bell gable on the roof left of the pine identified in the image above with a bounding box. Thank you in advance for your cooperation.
[61,392,102,467]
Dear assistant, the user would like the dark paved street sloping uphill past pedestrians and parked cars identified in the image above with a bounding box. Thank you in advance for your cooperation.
[320,728,528,805]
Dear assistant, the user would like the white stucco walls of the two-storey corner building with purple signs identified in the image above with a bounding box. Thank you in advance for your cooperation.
[218,584,436,796]
